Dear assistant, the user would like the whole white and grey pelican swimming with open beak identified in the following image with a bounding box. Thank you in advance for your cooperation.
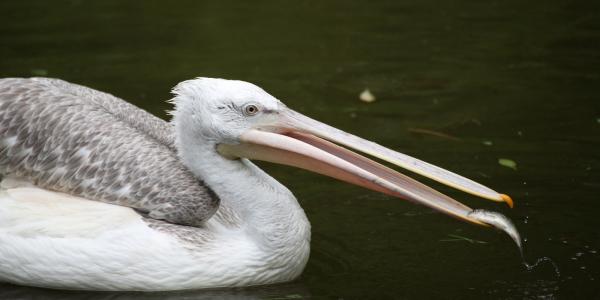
[0,78,512,291]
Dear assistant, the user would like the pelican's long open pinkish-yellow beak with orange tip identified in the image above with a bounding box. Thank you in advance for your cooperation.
[218,108,513,225]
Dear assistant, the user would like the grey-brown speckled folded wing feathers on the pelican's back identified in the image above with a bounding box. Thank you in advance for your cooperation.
[0,78,219,226]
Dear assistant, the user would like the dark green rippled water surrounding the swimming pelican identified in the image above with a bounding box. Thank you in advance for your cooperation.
[0,0,600,299]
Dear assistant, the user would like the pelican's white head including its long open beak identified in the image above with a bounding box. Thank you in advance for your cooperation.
[173,78,512,225]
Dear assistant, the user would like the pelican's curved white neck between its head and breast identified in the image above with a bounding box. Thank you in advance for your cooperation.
[170,125,310,249]
